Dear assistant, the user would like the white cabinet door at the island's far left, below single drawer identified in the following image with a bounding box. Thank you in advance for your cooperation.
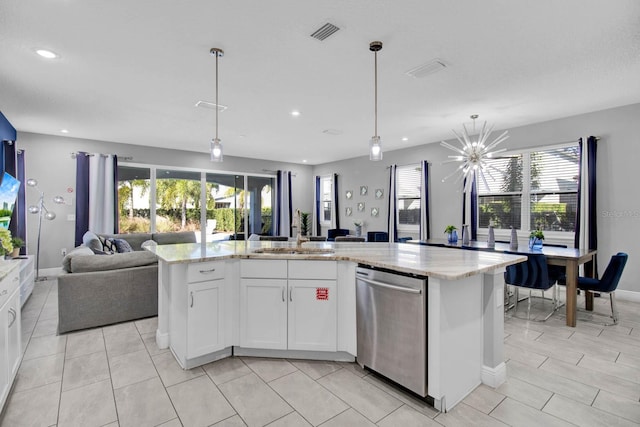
[187,280,225,359]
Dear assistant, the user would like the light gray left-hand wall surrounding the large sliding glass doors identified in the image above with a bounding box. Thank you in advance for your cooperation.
[16,132,314,269]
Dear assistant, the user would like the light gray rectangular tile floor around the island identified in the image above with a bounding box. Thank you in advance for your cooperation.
[0,280,640,427]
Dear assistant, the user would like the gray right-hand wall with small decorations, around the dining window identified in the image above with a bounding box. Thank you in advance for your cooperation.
[313,104,640,292]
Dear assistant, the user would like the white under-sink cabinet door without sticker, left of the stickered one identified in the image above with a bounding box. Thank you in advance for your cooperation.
[240,279,287,350]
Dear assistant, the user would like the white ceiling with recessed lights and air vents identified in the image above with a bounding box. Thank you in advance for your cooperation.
[0,0,640,164]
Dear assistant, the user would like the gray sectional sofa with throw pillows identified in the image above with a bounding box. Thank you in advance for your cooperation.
[58,231,196,334]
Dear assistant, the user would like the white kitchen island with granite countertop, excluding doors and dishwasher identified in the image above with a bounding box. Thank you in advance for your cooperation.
[148,241,526,411]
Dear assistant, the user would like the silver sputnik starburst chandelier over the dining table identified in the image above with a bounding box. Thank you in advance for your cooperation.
[440,114,509,193]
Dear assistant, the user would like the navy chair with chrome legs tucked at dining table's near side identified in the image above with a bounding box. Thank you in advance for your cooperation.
[504,252,558,321]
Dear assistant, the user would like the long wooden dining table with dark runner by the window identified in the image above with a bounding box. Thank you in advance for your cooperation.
[406,239,597,327]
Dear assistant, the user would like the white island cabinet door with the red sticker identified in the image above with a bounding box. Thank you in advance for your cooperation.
[288,279,338,351]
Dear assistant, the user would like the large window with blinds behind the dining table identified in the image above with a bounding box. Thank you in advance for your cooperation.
[478,145,579,232]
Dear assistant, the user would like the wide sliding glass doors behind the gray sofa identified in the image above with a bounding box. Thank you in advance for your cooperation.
[118,164,275,242]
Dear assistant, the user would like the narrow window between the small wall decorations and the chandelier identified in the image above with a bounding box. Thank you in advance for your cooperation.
[396,164,420,231]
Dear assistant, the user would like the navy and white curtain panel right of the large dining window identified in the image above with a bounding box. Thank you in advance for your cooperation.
[574,136,598,277]
